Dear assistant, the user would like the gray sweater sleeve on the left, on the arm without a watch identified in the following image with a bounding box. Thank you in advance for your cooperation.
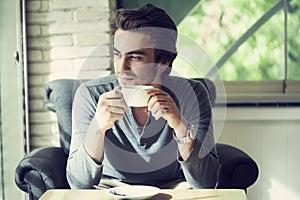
[66,84,103,189]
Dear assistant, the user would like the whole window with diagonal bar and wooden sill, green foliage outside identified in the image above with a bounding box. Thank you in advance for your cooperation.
[173,0,300,105]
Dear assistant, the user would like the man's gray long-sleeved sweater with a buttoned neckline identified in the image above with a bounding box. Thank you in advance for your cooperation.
[67,75,219,188]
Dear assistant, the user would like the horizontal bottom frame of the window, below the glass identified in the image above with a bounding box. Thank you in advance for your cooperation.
[215,80,300,106]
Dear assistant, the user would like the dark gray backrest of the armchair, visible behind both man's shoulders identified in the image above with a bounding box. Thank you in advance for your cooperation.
[45,78,216,155]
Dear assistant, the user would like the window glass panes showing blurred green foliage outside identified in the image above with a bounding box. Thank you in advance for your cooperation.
[173,0,300,81]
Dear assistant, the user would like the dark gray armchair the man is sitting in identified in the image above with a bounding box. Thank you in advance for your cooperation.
[15,79,258,200]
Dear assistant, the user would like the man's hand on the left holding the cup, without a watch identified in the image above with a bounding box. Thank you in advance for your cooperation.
[95,86,127,133]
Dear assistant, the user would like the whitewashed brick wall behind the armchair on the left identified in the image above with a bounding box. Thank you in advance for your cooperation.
[26,0,115,149]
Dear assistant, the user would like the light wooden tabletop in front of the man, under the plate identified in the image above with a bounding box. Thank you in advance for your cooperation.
[40,189,247,200]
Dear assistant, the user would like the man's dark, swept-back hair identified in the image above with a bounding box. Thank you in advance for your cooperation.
[112,4,177,74]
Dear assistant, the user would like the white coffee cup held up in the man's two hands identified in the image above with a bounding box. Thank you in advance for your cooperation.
[120,85,153,107]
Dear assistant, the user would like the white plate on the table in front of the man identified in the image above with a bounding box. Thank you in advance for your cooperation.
[108,185,160,199]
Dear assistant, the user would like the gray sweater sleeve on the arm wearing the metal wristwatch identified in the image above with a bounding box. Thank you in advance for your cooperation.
[179,80,220,188]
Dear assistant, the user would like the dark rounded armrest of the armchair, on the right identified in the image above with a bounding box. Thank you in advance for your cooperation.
[216,143,258,190]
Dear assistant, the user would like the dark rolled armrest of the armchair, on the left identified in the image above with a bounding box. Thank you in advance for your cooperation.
[15,147,70,200]
